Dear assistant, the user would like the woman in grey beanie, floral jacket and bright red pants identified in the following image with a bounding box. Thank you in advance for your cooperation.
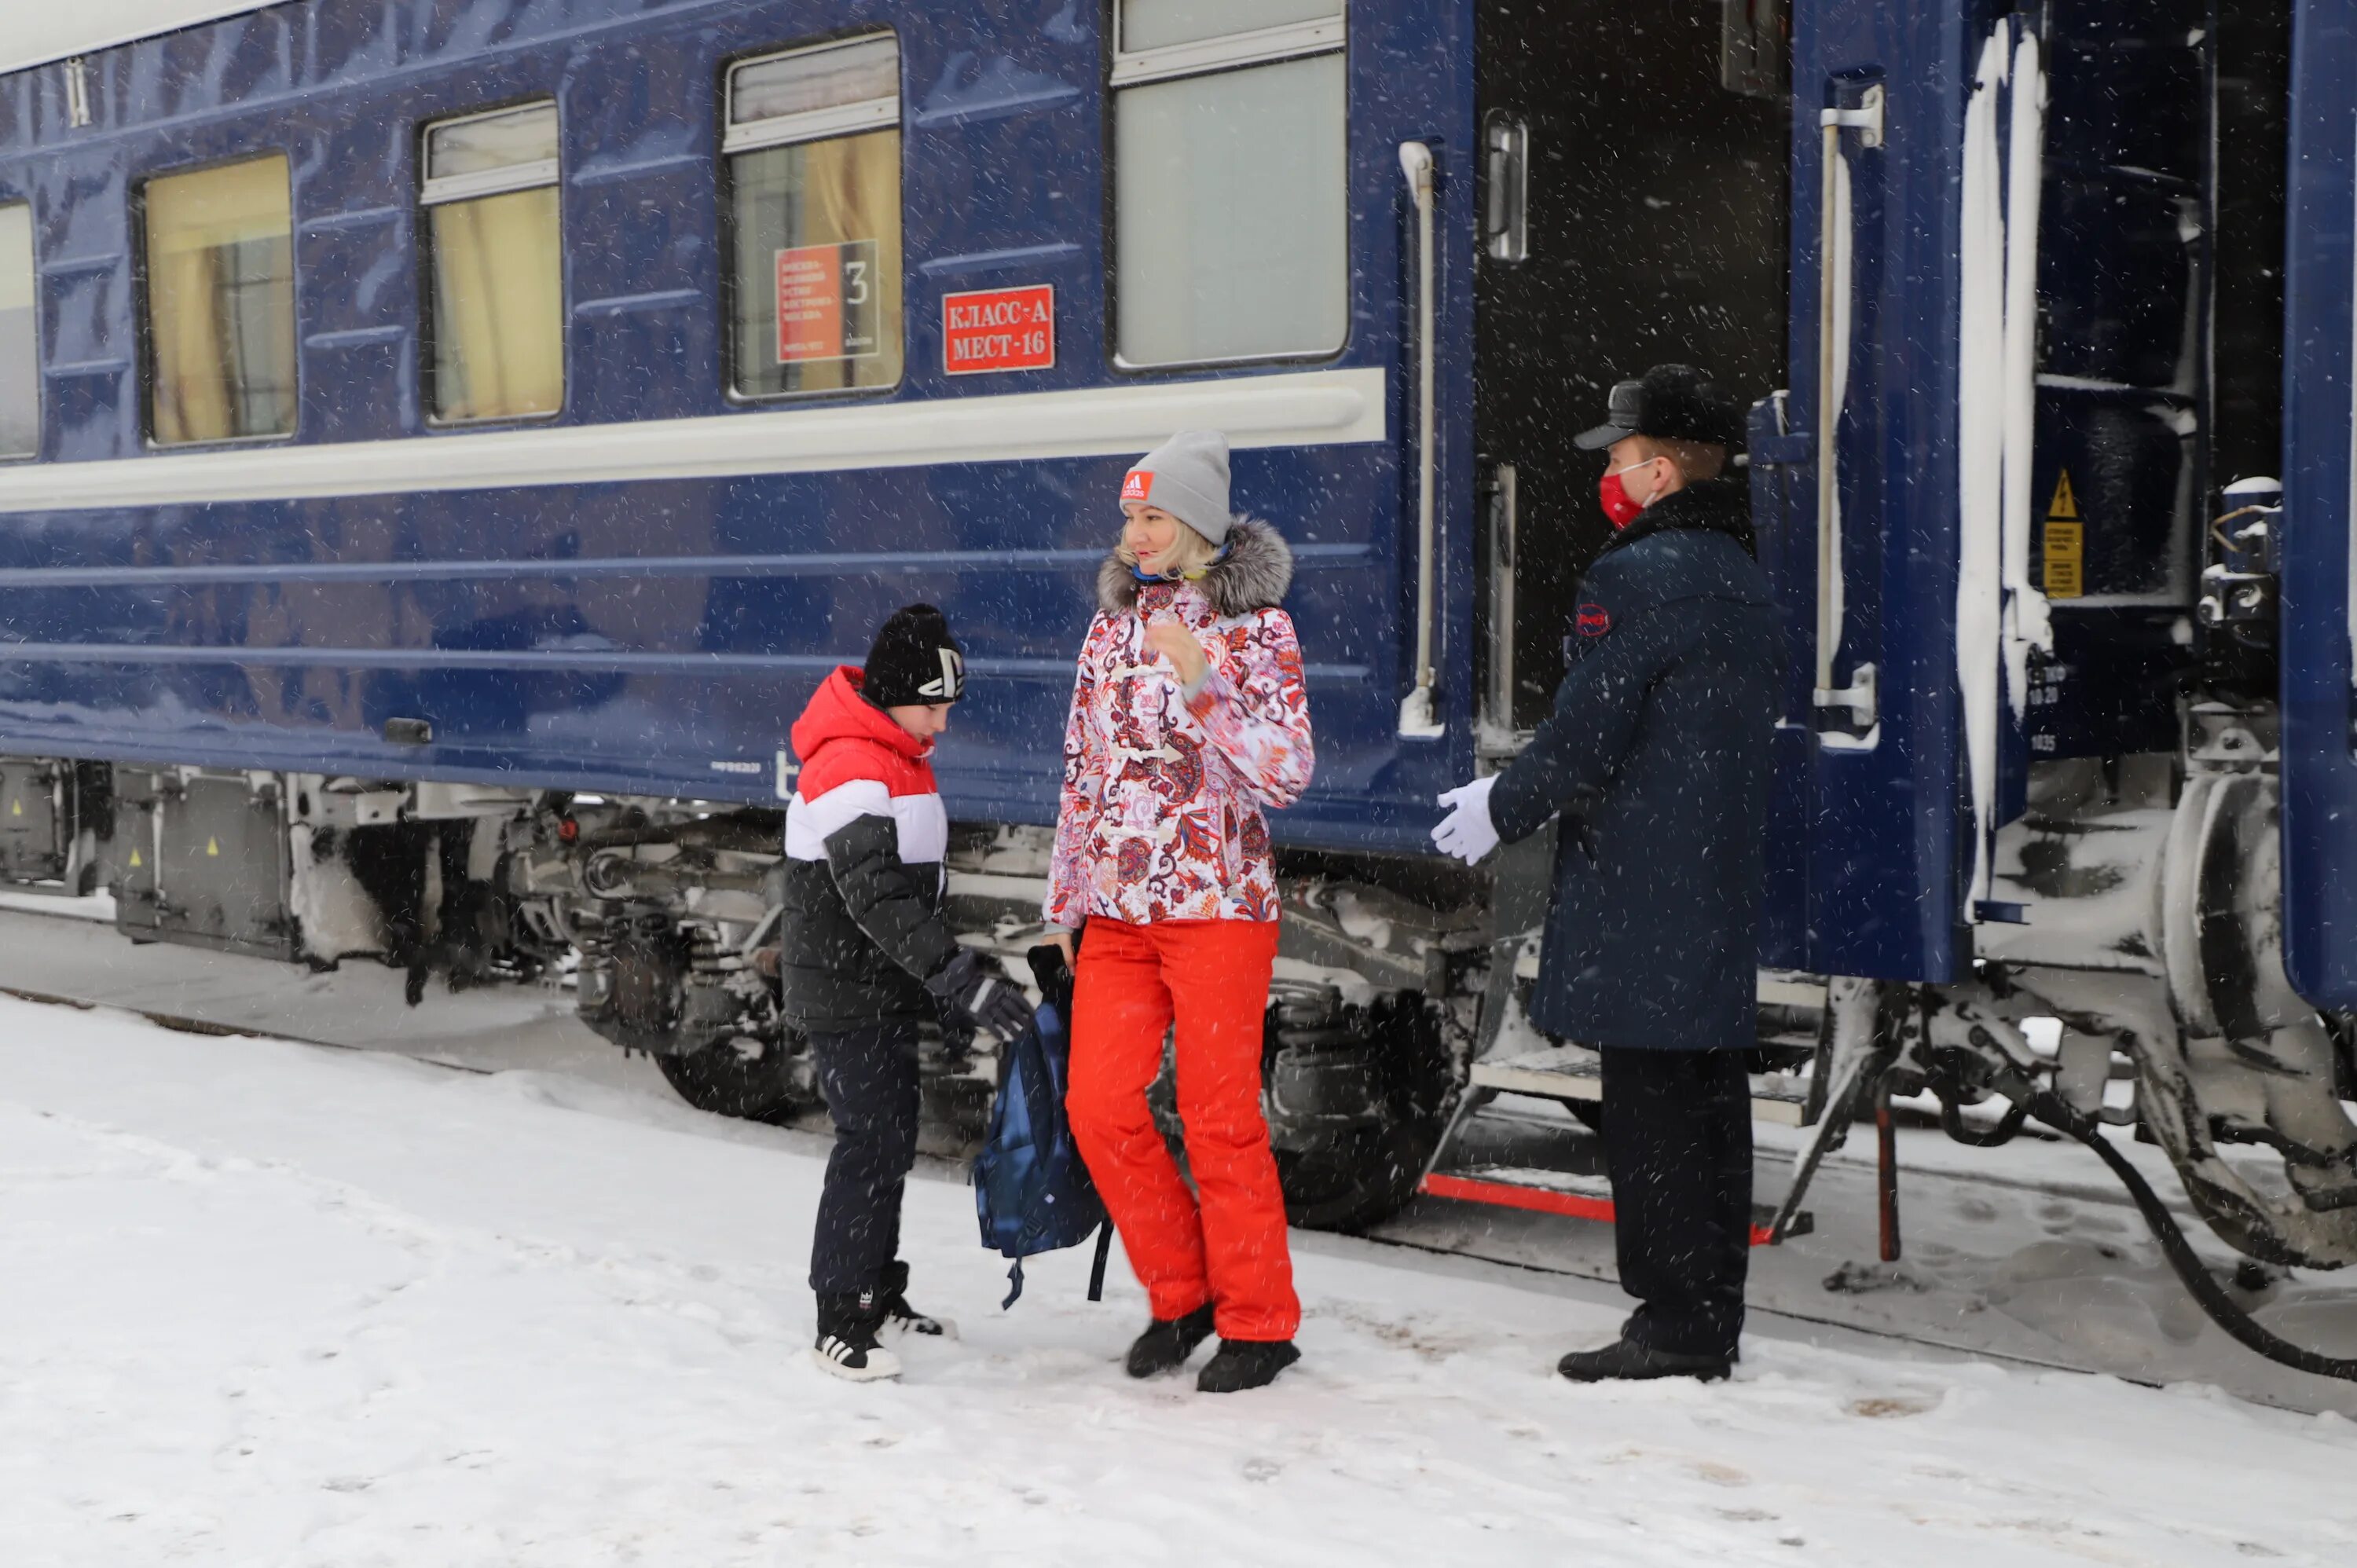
[1047,431,1315,1394]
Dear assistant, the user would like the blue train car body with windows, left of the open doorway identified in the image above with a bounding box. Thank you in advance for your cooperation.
[0,0,1471,830]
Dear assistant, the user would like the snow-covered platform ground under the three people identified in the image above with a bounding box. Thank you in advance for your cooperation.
[0,1000,2357,1568]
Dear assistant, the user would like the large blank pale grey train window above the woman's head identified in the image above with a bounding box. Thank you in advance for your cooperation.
[1113,0,1351,365]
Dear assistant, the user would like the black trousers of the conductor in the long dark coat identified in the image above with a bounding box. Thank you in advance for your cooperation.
[1603,1045,1751,1356]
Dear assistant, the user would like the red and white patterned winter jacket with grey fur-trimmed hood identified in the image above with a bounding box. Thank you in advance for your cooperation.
[1047,518,1315,927]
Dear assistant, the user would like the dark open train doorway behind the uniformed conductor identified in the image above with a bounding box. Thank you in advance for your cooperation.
[1473,0,1789,747]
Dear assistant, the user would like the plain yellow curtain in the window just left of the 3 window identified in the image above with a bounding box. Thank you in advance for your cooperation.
[434,186,566,419]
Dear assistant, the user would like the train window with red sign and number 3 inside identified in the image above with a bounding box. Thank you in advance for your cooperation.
[721,33,903,398]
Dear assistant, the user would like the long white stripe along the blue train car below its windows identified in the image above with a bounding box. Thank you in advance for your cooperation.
[0,370,1388,514]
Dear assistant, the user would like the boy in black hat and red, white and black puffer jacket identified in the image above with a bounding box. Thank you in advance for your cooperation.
[778,603,1032,1382]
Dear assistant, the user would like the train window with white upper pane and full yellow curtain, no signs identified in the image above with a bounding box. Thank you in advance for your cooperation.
[420,104,566,422]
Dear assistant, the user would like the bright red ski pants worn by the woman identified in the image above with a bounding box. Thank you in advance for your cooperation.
[1065,918,1301,1339]
